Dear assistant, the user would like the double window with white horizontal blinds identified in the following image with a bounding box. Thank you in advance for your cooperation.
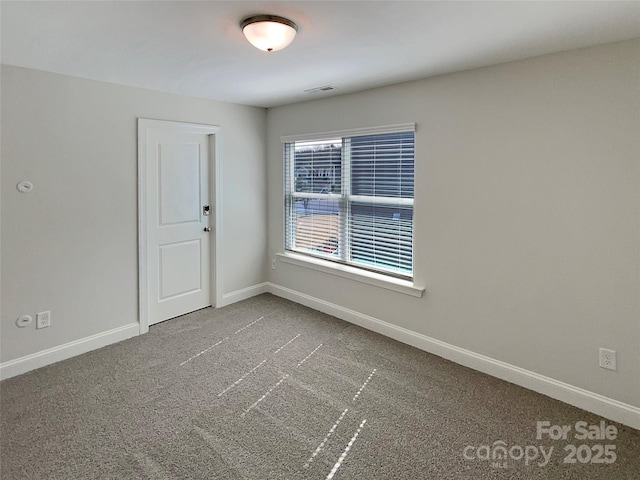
[283,124,415,278]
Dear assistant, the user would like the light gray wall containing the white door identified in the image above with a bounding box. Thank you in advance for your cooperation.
[0,65,267,362]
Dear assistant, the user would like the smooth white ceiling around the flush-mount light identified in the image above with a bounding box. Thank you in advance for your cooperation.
[0,0,640,107]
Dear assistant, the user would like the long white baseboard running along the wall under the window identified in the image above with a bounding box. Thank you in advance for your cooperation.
[268,283,640,429]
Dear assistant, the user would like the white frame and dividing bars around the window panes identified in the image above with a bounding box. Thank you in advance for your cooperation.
[281,123,416,282]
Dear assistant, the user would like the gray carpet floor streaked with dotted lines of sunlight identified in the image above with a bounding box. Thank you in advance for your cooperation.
[0,294,640,480]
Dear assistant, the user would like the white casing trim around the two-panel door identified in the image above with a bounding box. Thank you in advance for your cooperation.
[138,118,223,334]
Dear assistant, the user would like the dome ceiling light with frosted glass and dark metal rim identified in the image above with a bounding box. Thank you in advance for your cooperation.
[240,15,298,52]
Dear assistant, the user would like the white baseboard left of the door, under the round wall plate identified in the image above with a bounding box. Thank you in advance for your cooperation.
[0,322,140,380]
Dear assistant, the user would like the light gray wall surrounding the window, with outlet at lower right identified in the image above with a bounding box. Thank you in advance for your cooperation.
[267,40,640,406]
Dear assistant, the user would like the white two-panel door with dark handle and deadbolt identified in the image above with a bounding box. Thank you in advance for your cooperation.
[141,122,214,325]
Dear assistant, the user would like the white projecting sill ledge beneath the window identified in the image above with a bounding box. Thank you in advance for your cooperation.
[276,253,424,298]
